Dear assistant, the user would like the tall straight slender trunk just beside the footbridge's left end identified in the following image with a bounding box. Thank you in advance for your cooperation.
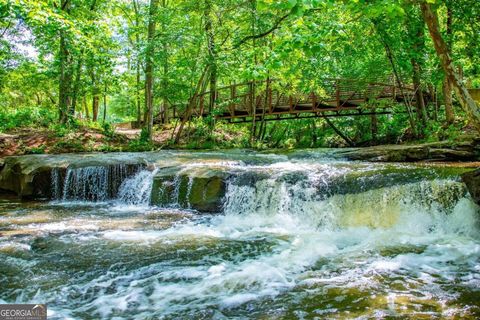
[144,0,158,140]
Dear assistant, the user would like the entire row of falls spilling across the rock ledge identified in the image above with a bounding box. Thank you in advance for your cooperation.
[51,161,467,228]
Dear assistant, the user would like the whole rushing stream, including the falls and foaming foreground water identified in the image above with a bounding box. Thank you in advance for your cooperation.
[0,151,480,319]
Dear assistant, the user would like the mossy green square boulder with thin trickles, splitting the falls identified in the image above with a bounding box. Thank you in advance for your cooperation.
[151,168,228,212]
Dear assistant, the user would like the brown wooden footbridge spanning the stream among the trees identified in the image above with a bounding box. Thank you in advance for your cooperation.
[159,79,429,123]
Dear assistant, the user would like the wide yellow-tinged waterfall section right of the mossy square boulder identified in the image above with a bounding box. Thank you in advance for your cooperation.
[224,168,467,228]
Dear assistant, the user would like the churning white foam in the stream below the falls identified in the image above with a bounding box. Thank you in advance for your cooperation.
[42,185,480,318]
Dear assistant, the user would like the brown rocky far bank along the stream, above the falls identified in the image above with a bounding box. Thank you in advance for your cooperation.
[0,128,480,162]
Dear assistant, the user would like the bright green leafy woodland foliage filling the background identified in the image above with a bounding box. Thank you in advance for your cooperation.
[0,0,480,152]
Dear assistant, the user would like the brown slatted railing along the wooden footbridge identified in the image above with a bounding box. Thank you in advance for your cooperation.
[162,79,420,119]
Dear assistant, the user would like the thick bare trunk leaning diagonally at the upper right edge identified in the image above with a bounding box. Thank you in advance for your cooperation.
[421,2,480,131]
